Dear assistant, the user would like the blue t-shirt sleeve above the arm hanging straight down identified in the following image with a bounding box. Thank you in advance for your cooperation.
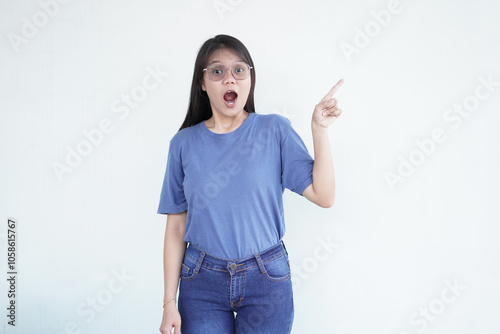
[157,140,187,214]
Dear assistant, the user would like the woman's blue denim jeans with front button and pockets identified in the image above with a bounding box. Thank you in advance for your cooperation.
[178,243,294,334]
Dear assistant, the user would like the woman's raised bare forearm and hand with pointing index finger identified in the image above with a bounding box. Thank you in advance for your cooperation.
[302,79,344,208]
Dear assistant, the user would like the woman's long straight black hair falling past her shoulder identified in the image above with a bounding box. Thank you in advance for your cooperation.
[178,35,255,131]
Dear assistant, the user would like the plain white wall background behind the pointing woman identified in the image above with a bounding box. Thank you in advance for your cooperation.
[0,0,500,334]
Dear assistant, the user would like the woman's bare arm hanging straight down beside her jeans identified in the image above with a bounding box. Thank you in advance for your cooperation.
[160,211,187,334]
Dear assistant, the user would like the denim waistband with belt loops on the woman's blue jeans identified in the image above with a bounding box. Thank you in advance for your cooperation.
[185,241,288,272]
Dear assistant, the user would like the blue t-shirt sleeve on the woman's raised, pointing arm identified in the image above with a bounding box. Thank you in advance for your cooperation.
[279,115,314,196]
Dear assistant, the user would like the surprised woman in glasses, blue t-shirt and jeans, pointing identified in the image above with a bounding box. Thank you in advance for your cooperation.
[158,35,343,334]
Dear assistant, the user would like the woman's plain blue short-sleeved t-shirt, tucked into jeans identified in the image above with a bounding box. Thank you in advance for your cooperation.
[158,113,314,260]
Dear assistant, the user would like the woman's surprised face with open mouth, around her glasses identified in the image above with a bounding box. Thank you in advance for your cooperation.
[201,49,252,116]
